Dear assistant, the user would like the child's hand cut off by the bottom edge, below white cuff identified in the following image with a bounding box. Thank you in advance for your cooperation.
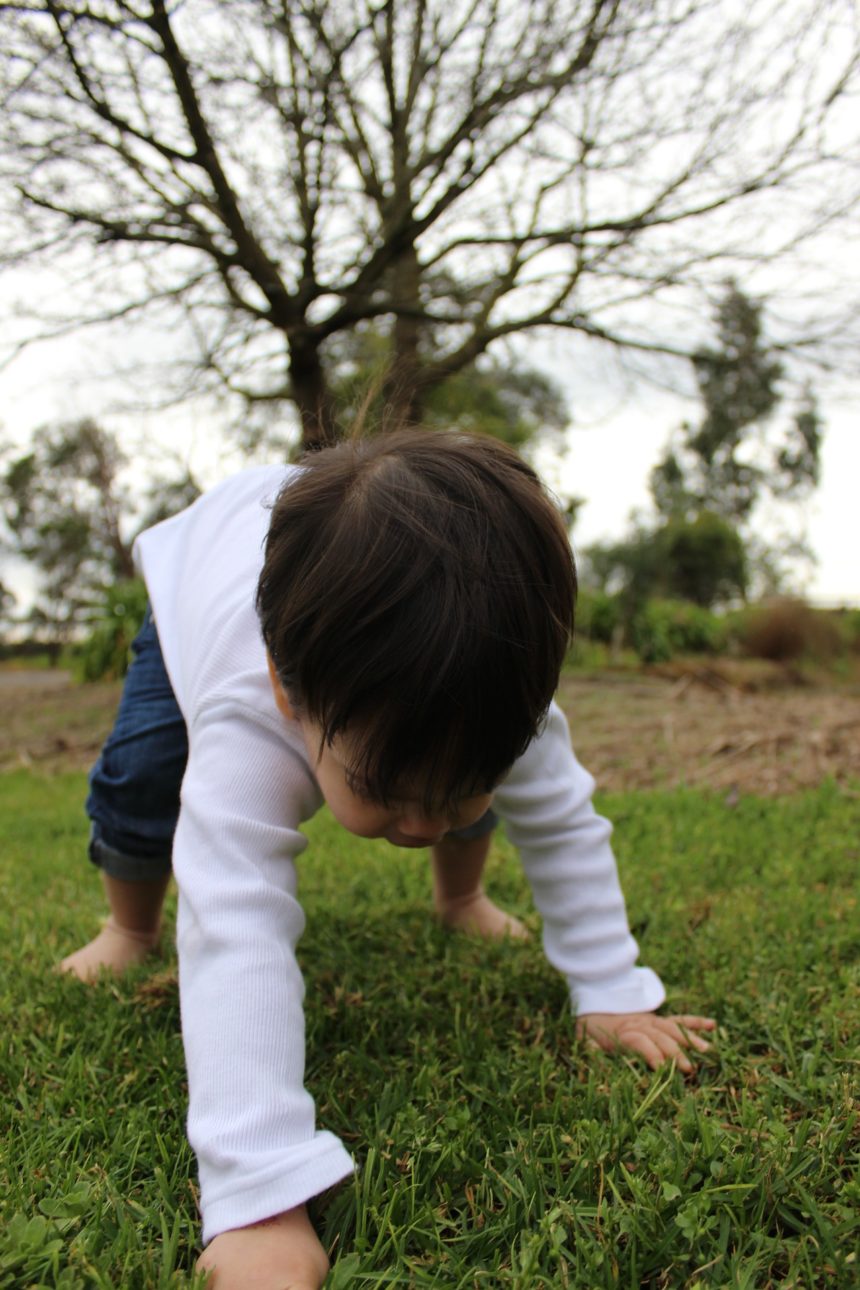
[197,1205,329,1290]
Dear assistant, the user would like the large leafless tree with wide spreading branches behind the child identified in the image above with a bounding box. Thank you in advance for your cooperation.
[0,0,857,445]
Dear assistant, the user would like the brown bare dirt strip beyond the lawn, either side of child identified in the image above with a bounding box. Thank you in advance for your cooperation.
[0,664,860,796]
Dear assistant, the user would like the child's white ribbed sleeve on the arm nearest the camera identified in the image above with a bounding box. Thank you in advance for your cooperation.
[174,707,353,1242]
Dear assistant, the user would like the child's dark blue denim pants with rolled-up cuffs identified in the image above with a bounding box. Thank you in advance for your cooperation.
[86,609,498,882]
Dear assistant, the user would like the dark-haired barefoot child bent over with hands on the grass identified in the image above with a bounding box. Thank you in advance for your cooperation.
[63,430,713,1290]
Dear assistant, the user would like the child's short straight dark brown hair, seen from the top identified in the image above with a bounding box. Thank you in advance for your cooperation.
[257,430,576,811]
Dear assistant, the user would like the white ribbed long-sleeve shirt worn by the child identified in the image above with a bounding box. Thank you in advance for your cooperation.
[135,466,664,1241]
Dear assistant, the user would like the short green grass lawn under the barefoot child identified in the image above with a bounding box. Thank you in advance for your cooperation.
[0,773,860,1290]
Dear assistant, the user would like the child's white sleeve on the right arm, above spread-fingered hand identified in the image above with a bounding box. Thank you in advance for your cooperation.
[494,703,665,1014]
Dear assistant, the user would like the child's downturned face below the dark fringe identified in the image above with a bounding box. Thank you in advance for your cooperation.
[269,660,493,846]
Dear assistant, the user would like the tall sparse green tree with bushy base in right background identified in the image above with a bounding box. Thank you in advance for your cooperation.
[587,283,823,620]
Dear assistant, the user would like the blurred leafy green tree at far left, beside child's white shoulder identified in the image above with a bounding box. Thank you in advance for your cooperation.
[0,419,199,650]
